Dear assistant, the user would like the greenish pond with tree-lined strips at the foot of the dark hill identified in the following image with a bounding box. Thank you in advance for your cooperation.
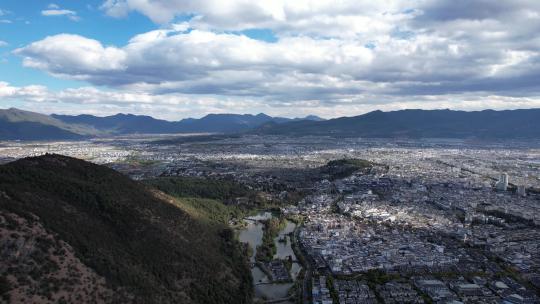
[238,212,301,303]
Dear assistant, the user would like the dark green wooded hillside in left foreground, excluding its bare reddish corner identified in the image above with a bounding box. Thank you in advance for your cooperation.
[0,155,252,303]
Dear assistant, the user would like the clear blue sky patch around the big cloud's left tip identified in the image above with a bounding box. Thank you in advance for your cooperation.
[0,0,156,90]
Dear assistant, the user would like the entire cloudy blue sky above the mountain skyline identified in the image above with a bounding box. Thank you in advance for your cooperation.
[0,0,540,119]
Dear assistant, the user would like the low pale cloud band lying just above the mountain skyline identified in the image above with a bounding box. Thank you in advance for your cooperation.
[0,82,540,120]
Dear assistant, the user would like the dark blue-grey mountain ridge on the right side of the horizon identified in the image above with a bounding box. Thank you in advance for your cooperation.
[254,109,540,139]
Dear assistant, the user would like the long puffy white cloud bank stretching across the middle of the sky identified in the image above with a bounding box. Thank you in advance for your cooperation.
[15,20,540,100]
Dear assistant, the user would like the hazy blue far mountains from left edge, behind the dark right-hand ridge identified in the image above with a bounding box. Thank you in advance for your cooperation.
[0,108,322,140]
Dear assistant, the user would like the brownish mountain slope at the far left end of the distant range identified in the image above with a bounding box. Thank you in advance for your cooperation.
[0,108,95,140]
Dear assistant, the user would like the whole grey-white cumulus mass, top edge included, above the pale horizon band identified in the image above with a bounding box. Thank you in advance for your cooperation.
[7,0,540,114]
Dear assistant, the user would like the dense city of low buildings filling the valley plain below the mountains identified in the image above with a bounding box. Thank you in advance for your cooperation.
[0,136,540,304]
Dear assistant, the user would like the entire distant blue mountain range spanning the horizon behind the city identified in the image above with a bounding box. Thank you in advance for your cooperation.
[0,108,540,140]
